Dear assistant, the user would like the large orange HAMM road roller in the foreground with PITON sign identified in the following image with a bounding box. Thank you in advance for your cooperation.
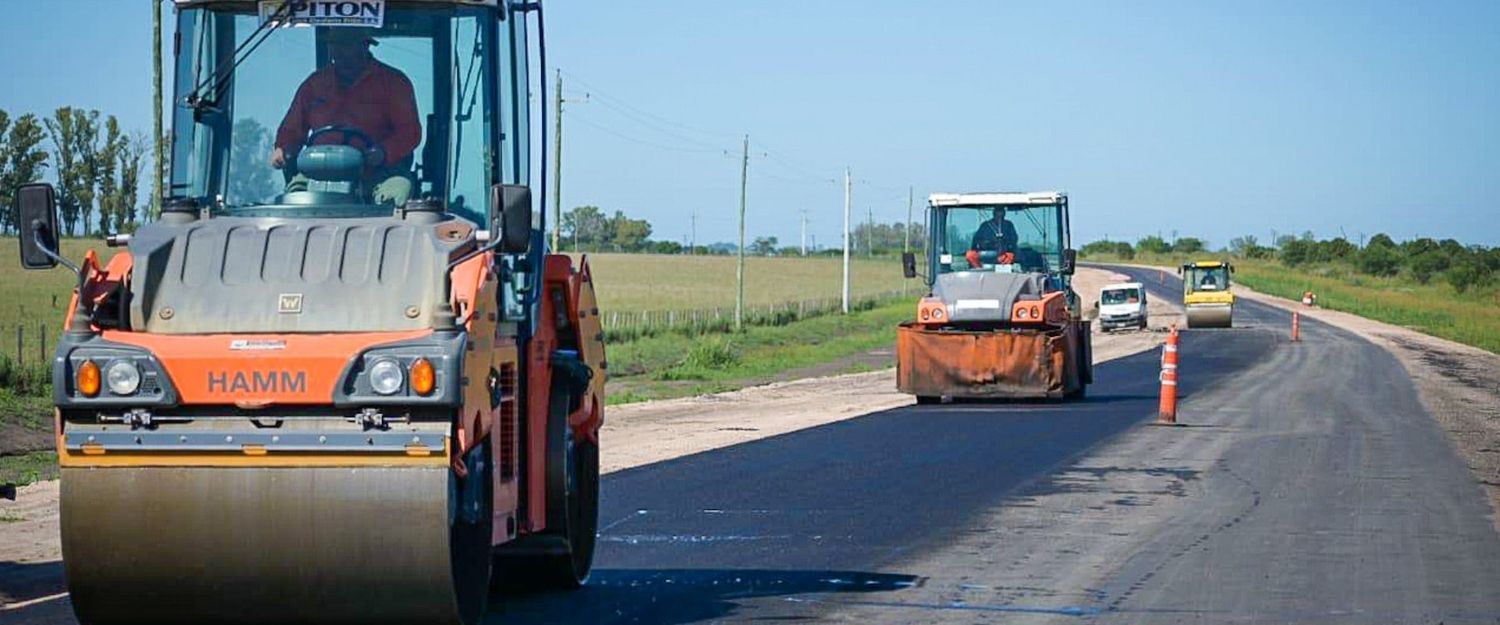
[15,0,605,625]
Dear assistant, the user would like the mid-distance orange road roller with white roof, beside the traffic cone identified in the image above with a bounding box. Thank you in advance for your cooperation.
[896,192,1094,403]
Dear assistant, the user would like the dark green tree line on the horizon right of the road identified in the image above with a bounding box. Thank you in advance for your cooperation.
[1079,232,1500,292]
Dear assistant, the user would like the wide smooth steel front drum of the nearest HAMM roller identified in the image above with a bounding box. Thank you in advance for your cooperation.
[62,462,489,625]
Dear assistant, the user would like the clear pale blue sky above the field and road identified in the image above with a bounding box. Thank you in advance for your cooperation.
[0,0,1500,246]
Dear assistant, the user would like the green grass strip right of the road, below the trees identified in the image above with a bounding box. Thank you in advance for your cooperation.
[1088,255,1500,354]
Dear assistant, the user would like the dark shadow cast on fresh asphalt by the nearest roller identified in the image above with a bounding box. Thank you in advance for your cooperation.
[488,568,918,625]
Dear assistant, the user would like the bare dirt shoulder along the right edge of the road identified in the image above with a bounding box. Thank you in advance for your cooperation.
[1235,285,1500,531]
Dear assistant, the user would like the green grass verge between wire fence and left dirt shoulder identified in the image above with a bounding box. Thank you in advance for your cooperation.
[606,300,915,403]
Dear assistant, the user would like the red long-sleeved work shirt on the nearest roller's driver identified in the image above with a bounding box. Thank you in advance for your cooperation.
[276,58,422,166]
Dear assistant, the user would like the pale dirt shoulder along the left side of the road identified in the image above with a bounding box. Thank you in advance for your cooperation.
[0,263,1181,604]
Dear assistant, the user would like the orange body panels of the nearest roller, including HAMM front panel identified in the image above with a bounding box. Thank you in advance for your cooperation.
[54,245,605,546]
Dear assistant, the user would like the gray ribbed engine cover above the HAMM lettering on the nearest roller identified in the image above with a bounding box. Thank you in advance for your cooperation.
[131,217,474,334]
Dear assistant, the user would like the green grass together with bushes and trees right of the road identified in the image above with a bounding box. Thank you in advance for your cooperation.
[1080,234,1500,354]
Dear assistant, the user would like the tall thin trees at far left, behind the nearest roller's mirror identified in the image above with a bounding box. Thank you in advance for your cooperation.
[0,106,152,235]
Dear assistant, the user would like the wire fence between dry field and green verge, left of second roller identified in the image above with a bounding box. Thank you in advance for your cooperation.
[600,291,908,343]
